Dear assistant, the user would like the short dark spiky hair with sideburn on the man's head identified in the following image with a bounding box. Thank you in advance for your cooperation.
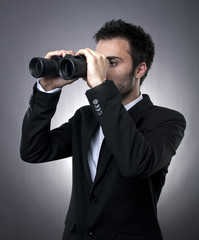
[93,19,155,85]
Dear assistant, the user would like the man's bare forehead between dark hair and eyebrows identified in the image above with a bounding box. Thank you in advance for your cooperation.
[96,38,130,57]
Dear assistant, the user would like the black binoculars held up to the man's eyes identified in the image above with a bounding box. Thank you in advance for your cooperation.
[29,54,87,80]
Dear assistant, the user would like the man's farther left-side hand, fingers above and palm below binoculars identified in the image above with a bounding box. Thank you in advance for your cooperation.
[40,50,77,91]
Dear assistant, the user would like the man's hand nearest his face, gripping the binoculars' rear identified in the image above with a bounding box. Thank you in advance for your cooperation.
[76,48,109,88]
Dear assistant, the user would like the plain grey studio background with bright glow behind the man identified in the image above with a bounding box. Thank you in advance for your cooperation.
[0,0,199,240]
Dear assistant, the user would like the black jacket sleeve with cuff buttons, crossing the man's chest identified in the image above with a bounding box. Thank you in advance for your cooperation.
[86,81,186,179]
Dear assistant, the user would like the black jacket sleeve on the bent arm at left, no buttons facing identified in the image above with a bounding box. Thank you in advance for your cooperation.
[20,85,72,163]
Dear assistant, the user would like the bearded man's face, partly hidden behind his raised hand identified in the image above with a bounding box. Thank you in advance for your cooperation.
[96,38,134,96]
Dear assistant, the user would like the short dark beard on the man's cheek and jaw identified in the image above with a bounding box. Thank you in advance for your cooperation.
[114,71,135,98]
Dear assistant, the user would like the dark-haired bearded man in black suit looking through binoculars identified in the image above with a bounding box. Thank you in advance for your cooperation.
[21,20,185,240]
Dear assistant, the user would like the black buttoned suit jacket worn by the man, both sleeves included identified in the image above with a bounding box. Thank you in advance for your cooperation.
[21,81,185,240]
